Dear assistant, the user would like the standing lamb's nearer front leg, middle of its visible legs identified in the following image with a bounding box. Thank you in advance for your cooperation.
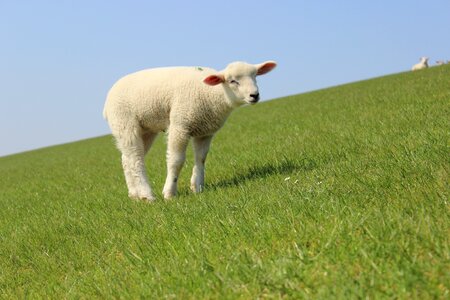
[163,128,189,199]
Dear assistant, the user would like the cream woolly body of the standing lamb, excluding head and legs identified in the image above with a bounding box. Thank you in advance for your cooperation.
[103,67,234,137]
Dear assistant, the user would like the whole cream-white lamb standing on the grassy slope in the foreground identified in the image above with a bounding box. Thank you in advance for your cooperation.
[103,61,277,201]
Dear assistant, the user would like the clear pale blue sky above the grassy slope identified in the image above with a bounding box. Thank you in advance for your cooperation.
[0,0,450,156]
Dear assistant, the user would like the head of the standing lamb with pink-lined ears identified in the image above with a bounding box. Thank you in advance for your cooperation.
[203,61,277,105]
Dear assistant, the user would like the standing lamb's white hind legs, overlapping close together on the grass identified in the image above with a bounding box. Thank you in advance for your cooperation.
[117,128,156,201]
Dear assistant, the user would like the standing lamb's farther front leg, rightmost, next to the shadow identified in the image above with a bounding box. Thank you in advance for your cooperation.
[191,136,212,193]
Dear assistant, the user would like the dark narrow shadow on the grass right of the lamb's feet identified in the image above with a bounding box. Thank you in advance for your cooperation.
[208,158,317,189]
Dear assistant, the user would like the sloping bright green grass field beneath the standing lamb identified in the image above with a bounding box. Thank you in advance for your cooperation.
[0,66,450,299]
